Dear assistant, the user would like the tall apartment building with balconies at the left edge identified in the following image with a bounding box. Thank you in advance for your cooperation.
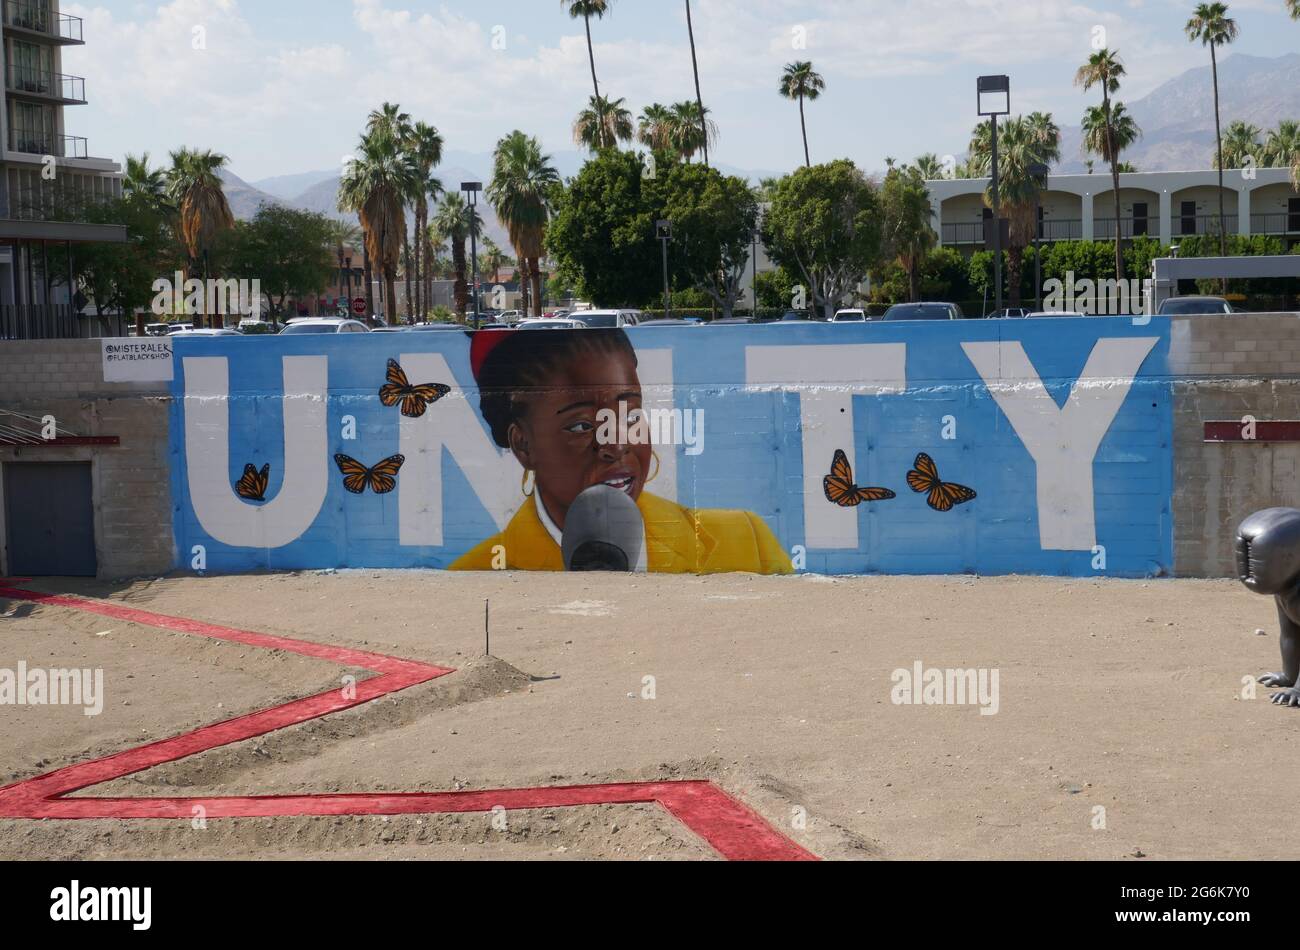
[0,0,126,339]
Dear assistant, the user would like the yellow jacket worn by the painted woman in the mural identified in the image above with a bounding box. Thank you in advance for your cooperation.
[451,493,794,574]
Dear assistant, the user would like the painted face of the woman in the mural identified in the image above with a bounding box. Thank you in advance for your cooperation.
[510,353,653,530]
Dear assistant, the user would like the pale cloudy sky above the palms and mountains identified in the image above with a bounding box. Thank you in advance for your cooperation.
[62,0,1300,182]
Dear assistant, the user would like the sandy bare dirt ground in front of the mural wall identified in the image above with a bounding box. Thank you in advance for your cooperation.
[0,572,1300,860]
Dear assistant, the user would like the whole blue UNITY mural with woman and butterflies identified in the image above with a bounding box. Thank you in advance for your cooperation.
[172,318,1173,576]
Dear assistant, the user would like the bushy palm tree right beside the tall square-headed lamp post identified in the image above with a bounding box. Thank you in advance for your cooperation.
[970,113,1061,307]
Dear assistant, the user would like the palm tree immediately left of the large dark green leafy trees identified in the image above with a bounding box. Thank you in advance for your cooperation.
[488,130,560,316]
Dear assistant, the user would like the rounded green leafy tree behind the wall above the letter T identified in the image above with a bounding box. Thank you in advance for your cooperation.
[763,160,881,318]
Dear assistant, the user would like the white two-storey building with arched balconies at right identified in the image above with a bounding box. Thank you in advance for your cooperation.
[926,169,1300,252]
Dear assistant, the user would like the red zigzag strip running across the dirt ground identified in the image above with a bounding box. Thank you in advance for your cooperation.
[0,578,816,860]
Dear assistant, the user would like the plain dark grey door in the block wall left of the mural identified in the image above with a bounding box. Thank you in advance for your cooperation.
[4,461,96,577]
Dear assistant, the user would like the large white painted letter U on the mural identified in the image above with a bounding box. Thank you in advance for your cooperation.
[183,356,329,548]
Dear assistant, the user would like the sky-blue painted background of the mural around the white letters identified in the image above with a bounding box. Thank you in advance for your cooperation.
[172,318,1173,577]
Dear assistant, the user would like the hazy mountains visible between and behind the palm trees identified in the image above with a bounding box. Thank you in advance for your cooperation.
[221,53,1300,233]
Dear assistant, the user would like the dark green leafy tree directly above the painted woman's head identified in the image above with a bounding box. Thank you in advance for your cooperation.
[546,149,660,307]
